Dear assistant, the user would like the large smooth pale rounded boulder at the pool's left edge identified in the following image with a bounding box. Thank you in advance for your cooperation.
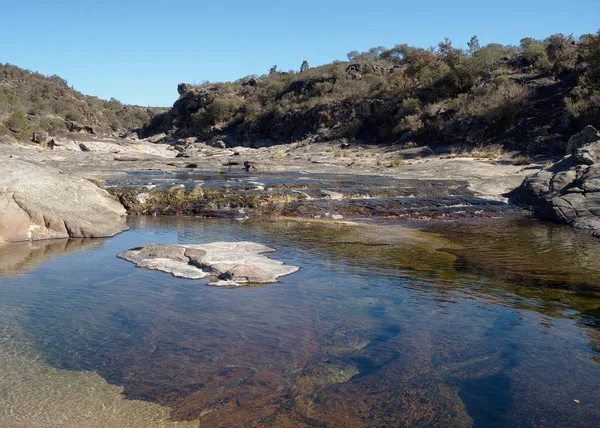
[0,158,127,242]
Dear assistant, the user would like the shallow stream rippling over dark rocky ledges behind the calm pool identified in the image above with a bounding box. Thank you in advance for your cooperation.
[107,169,520,221]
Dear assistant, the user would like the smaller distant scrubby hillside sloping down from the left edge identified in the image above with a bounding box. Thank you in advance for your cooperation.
[0,63,165,139]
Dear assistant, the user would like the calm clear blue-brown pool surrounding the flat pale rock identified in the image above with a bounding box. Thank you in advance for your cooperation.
[0,218,600,427]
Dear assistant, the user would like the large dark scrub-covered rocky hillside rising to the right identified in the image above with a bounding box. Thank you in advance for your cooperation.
[149,32,600,154]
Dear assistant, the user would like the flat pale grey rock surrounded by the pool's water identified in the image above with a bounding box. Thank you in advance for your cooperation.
[118,241,300,285]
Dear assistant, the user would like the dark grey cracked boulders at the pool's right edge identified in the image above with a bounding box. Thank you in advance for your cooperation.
[512,126,600,237]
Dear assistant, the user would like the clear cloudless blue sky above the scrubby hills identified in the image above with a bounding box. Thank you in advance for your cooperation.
[0,0,600,106]
